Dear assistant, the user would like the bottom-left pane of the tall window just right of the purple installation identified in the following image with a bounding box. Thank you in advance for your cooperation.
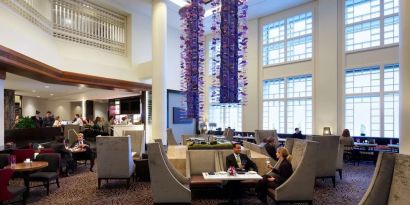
[263,101,285,133]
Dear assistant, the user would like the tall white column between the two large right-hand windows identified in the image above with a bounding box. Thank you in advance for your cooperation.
[312,0,339,135]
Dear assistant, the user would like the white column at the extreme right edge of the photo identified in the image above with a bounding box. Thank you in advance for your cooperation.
[399,0,410,154]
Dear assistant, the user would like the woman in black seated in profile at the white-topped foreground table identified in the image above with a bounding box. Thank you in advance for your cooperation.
[255,147,293,203]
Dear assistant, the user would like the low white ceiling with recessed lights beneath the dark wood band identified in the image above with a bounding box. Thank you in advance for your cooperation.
[4,73,140,102]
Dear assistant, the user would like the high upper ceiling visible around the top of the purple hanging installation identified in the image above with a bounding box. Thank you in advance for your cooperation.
[95,0,313,32]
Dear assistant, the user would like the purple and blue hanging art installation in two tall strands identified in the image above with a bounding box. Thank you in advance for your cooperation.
[179,0,248,119]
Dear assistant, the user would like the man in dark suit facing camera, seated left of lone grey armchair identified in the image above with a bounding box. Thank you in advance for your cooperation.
[71,133,95,172]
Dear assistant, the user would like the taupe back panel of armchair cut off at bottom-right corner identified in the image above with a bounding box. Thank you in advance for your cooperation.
[386,154,410,205]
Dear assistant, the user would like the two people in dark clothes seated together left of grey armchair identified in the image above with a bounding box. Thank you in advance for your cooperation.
[51,133,95,176]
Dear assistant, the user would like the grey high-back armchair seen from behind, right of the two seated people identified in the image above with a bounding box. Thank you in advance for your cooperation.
[96,136,135,188]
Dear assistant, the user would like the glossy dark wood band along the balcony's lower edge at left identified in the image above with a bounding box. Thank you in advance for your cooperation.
[0,45,151,92]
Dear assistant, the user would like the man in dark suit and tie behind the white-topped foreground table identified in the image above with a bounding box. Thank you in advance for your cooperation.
[226,143,258,172]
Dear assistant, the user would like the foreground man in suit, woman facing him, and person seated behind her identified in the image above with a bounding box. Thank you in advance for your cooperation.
[226,143,293,203]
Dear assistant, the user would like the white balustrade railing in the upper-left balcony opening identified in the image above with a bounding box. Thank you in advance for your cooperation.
[2,0,127,55]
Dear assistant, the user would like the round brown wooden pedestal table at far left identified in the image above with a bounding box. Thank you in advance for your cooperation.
[5,161,48,196]
